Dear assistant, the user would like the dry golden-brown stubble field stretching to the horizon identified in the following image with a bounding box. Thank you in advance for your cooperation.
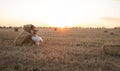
[0,29,120,71]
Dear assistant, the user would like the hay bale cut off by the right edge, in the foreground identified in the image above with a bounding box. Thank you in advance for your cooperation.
[103,44,120,56]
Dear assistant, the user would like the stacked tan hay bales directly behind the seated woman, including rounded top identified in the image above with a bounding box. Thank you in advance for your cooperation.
[14,24,34,46]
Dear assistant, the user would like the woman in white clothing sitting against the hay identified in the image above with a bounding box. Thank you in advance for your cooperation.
[30,25,43,45]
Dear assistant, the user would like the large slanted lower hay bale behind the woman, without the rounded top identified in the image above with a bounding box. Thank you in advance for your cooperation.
[14,31,34,46]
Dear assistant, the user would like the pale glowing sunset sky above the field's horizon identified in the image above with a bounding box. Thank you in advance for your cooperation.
[0,0,120,27]
